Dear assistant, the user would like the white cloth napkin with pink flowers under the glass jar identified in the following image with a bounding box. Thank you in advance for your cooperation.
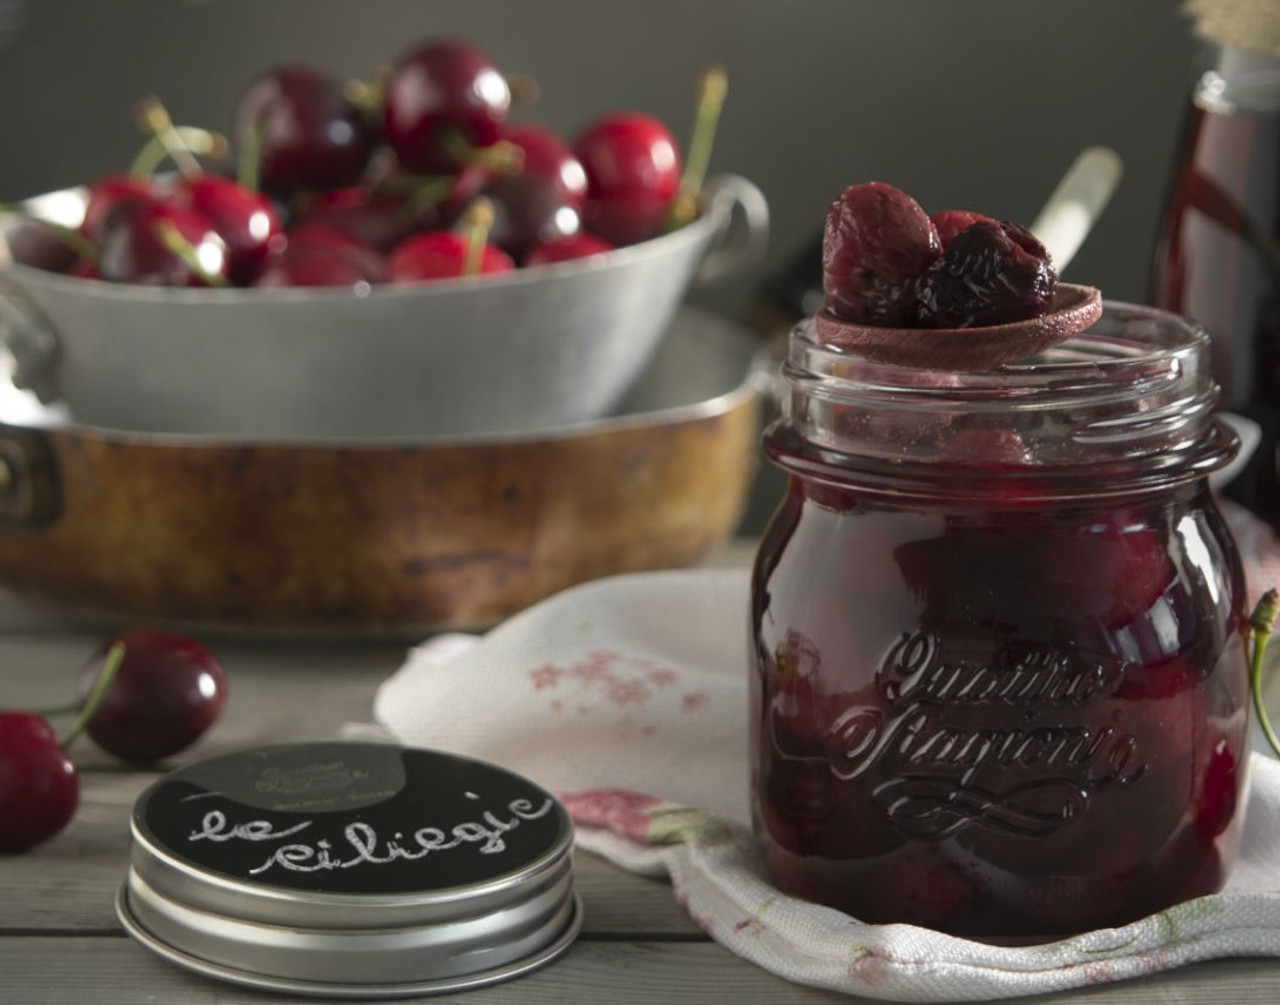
[374,496,1280,1001]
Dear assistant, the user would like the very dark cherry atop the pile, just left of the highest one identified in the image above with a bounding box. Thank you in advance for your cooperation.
[232,65,376,195]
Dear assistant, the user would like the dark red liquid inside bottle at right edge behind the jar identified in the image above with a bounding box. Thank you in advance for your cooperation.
[1152,101,1280,527]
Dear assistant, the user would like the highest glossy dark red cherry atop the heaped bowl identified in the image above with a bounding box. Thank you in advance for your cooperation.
[383,40,511,174]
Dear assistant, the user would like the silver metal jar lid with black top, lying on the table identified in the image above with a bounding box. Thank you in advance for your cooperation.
[116,743,581,997]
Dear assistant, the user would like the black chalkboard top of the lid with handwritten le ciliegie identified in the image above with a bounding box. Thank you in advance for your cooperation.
[136,743,570,894]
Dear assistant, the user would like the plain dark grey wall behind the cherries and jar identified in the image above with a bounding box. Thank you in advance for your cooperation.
[0,0,1198,522]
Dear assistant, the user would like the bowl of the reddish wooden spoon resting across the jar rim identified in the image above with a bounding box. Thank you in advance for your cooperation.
[814,283,1102,370]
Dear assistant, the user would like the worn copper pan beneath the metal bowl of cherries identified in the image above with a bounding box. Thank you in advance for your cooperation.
[0,310,769,636]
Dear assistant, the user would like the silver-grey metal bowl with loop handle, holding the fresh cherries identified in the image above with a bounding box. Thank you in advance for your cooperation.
[0,175,768,442]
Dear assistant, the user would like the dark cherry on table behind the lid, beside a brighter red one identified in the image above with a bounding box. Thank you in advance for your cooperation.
[79,629,227,764]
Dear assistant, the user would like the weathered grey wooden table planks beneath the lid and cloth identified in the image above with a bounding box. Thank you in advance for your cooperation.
[0,568,1280,1005]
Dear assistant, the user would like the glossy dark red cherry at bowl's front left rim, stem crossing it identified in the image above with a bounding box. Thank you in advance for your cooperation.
[99,202,230,287]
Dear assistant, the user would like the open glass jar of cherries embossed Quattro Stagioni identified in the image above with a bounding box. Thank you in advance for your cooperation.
[750,303,1249,941]
